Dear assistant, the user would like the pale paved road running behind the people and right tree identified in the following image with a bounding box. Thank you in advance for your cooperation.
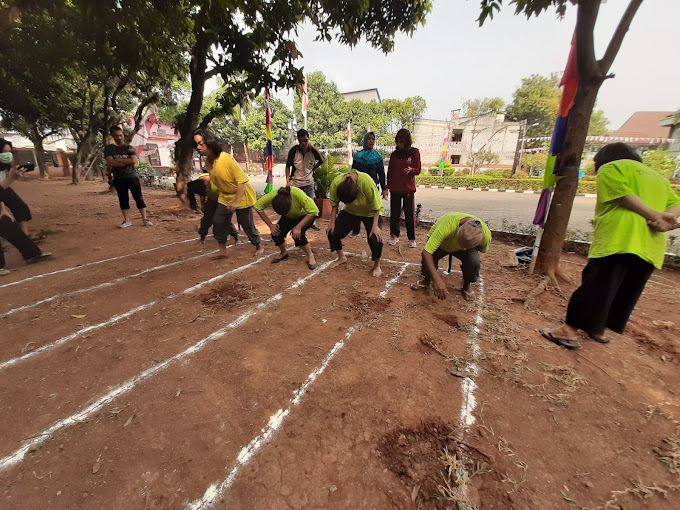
[246,177,595,232]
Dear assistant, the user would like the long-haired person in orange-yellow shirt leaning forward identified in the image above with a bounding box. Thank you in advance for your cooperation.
[194,129,264,259]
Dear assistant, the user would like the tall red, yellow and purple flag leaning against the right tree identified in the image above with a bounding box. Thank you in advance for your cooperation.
[533,35,578,227]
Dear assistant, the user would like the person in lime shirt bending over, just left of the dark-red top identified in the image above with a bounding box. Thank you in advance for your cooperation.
[327,170,385,277]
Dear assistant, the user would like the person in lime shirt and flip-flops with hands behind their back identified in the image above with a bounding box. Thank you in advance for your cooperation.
[541,143,680,349]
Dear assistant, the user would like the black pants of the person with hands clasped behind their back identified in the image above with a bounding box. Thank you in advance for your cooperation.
[566,253,654,335]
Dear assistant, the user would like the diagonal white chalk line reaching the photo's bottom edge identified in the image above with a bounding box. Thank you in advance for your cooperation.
[187,262,409,510]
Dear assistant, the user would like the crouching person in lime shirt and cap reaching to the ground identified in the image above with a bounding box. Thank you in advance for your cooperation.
[411,212,491,301]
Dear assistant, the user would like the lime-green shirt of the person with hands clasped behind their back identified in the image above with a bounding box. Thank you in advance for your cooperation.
[588,159,680,269]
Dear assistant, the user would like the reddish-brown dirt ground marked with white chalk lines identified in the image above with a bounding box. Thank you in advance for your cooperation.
[0,179,680,510]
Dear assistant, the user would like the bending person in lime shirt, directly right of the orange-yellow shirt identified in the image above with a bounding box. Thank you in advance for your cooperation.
[255,186,319,269]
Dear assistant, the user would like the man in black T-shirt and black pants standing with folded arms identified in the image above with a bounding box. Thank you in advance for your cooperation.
[104,126,153,228]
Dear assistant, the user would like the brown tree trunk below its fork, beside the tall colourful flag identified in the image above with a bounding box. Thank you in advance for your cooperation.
[536,81,601,281]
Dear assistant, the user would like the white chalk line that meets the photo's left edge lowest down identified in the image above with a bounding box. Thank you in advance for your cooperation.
[0,261,331,470]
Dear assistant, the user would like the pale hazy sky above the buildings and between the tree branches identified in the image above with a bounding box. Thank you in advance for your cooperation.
[277,0,680,130]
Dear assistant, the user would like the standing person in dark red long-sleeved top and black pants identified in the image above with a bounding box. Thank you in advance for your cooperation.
[383,129,420,248]
